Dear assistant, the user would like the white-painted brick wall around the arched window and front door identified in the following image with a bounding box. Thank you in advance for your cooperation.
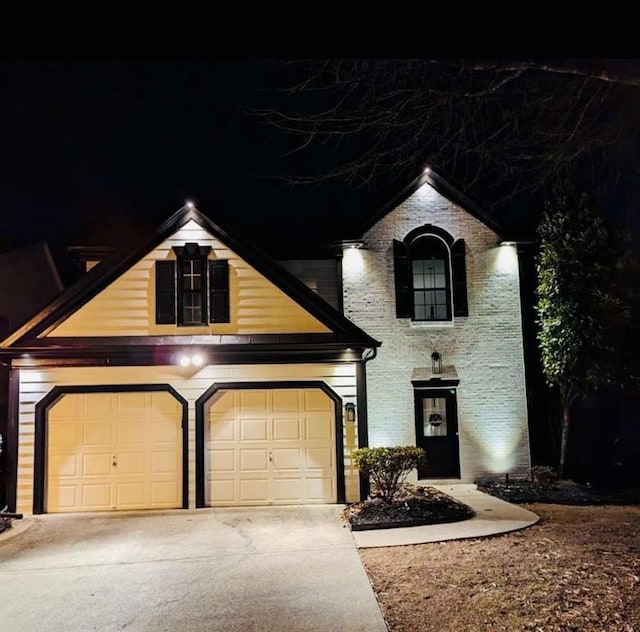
[343,184,530,482]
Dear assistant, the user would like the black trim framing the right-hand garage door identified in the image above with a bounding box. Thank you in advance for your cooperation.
[196,380,346,508]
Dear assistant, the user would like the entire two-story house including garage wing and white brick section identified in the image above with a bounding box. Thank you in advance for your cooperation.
[0,168,530,513]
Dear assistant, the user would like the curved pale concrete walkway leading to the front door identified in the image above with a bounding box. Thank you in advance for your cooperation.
[352,484,539,549]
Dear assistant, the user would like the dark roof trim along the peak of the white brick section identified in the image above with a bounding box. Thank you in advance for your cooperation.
[362,168,505,236]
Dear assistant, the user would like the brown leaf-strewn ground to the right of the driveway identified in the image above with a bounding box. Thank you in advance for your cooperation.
[360,504,640,632]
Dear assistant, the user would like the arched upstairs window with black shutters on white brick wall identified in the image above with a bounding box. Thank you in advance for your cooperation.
[393,225,468,322]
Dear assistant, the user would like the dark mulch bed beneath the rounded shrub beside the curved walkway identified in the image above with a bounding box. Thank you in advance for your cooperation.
[342,483,475,531]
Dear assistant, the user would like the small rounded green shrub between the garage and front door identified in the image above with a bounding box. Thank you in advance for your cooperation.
[353,445,426,503]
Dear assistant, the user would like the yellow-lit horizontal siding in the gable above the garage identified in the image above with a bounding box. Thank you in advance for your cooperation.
[47,221,329,337]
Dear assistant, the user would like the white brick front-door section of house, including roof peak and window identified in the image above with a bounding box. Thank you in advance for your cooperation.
[342,170,531,482]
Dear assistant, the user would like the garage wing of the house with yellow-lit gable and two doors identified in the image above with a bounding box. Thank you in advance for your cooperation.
[0,205,379,513]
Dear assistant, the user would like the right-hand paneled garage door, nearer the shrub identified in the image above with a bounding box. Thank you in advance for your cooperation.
[205,388,336,506]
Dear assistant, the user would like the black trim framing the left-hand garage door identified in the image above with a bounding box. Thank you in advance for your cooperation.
[33,384,189,514]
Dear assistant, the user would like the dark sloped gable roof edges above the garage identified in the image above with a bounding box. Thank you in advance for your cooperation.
[0,205,381,349]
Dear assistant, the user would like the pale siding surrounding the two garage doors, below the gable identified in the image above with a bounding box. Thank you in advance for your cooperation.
[18,363,359,514]
